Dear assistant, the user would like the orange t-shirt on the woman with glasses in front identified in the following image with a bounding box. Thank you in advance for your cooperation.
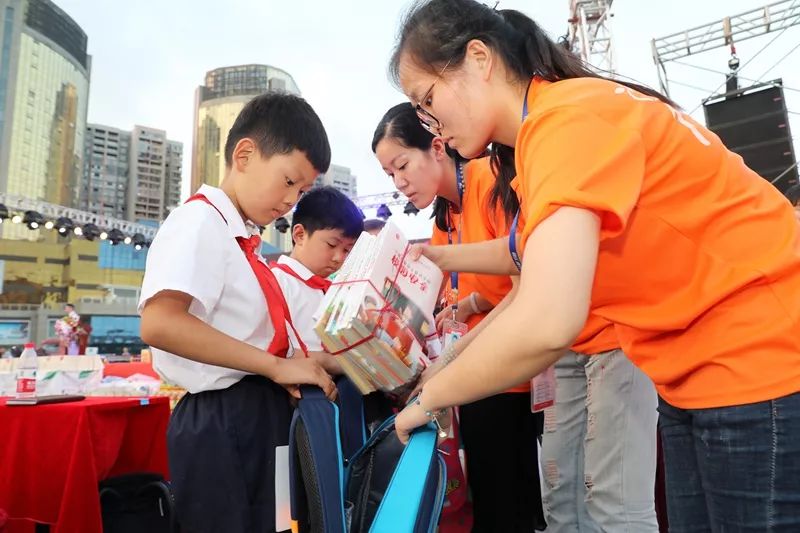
[515,78,800,408]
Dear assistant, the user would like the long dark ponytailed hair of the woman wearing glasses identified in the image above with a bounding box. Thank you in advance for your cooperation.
[389,0,674,220]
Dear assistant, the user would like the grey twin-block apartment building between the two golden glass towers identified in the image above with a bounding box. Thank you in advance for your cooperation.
[80,124,183,222]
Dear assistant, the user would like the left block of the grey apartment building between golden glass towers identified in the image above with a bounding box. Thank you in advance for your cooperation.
[80,124,131,220]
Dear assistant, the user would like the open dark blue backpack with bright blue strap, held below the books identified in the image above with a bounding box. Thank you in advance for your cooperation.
[289,383,447,533]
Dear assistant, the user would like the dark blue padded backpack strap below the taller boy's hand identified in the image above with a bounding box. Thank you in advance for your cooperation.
[289,386,346,533]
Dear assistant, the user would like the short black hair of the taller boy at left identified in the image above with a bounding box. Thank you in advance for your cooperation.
[225,91,331,173]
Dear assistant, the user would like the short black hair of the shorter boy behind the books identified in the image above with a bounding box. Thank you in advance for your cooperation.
[292,186,364,239]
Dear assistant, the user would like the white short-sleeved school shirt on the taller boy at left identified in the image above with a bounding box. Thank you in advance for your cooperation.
[139,185,274,393]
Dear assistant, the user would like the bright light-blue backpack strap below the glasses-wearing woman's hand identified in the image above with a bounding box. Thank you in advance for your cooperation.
[370,425,439,533]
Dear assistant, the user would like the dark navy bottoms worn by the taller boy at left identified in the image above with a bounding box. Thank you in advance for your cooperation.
[167,376,292,533]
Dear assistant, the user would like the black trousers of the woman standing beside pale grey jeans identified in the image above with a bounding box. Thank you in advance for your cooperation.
[460,392,545,533]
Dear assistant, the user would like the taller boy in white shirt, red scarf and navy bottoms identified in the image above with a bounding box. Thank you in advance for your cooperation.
[139,93,335,533]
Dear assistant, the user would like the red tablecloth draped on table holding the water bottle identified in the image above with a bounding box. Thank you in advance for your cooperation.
[0,397,169,533]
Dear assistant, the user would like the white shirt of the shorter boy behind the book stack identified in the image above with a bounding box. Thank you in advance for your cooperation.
[272,255,325,354]
